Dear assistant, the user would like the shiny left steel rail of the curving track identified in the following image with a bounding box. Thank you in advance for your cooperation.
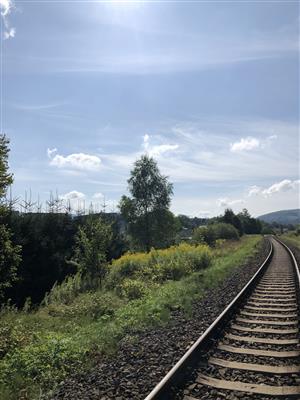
[144,241,274,400]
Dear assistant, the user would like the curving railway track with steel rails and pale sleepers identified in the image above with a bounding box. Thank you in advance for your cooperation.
[145,238,300,400]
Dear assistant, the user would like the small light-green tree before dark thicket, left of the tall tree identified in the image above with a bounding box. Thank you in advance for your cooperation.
[72,218,112,284]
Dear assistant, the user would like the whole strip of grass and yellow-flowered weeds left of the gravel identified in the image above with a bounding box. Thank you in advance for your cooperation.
[0,236,261,399]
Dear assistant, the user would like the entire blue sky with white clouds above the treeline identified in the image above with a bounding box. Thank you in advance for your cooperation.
[0,0,299,216]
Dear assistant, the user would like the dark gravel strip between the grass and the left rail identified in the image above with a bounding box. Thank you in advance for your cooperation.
[52,240,269,400]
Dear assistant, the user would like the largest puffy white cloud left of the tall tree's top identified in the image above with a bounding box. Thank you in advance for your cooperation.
[50,150,101,171]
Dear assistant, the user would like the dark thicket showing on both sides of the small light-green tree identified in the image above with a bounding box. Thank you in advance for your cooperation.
[6,212,128,307]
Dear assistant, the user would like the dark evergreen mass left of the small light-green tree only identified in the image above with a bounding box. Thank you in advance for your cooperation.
[8,213,78,307]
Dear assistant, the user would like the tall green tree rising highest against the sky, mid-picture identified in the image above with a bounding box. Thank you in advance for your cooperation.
[119,155,179,251]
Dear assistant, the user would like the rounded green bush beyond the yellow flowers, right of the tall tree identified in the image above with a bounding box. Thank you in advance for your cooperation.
[193,222,239,246]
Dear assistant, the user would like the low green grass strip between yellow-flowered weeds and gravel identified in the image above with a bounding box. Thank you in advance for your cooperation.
[0,236,261,399]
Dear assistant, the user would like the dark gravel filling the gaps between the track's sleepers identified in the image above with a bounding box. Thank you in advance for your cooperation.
[182,241,300,400]
